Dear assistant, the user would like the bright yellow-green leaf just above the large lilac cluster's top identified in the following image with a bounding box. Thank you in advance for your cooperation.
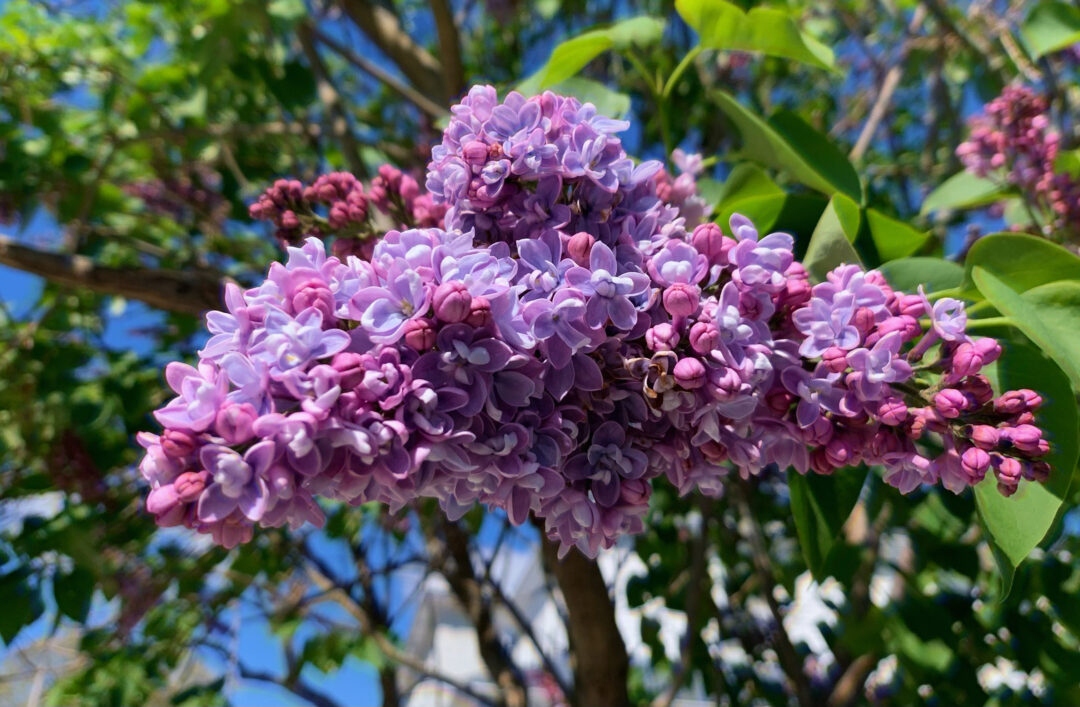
[517,16,664,90]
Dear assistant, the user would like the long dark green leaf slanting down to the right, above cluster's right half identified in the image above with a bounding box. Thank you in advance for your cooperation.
[716,91,863,202]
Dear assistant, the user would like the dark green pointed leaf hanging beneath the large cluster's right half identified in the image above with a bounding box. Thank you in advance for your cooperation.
[787,468,866,581]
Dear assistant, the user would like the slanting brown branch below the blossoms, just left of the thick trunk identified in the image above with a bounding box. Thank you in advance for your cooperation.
[441,522,528,707]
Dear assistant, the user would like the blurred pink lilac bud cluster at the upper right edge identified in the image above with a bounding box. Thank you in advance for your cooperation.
[956,85,1080,241]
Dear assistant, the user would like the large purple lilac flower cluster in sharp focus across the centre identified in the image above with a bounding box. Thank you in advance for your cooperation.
[139,87,1047,556]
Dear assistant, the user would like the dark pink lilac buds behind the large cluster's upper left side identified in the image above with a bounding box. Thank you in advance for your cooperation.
[248,164,446,258]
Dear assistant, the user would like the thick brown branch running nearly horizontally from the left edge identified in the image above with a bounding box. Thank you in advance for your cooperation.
[0,235,221,316]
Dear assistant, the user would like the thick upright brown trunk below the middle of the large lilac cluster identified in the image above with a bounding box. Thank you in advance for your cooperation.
[541,531,630,707]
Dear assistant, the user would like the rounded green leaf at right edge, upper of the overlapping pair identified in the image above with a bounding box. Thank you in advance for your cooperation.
[961,233,1080,297]
